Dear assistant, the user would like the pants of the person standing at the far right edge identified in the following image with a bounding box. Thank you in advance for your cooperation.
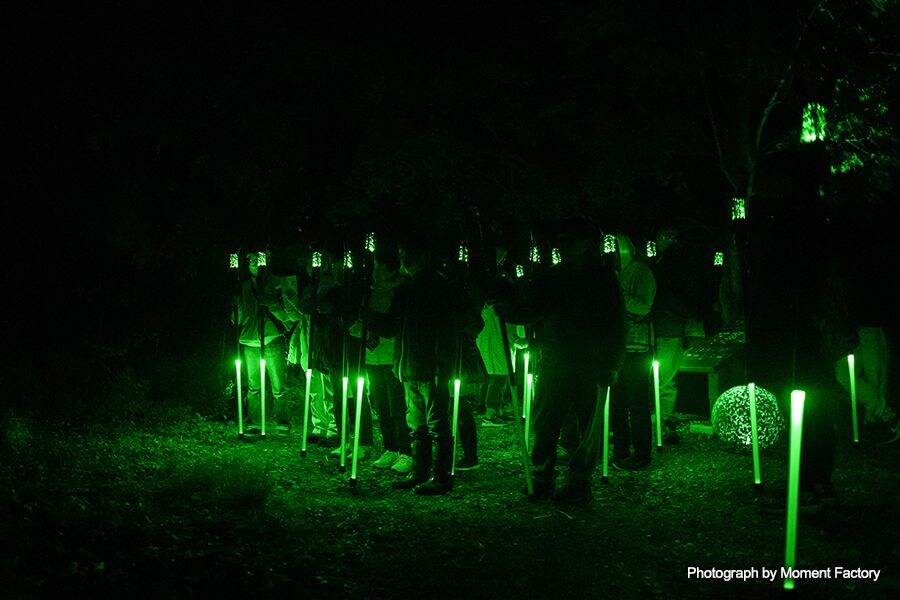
[834,327,894,423]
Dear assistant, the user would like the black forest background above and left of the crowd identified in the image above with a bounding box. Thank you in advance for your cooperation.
[2,0,900,414]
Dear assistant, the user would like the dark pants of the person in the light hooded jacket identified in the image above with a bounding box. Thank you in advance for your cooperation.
[609,352,653,459]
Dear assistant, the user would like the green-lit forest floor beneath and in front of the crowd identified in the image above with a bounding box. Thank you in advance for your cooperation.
[0,412,900,599]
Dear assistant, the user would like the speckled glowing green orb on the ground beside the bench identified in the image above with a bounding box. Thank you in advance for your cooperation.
[712,385,784,448]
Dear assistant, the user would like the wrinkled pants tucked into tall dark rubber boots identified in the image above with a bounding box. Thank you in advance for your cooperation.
[403,381,453,482]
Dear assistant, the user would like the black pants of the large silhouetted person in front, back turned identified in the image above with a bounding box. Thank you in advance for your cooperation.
[531,369,606,485]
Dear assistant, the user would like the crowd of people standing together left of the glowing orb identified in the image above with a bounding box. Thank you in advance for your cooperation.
[235,214,886,504]
